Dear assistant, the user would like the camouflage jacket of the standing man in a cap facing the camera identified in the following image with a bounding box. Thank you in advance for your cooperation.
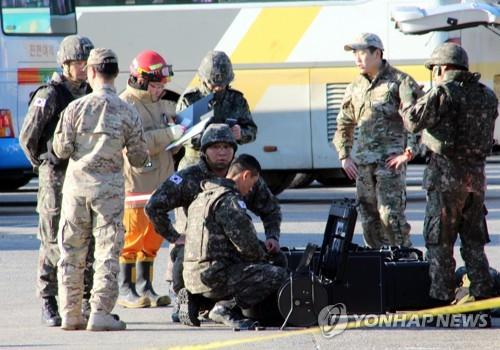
[333,61,422,165]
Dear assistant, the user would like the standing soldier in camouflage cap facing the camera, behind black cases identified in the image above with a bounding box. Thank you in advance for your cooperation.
[334,33,421,249]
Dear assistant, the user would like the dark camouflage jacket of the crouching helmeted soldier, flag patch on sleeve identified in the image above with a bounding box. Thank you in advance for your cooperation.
[145,159,281,242]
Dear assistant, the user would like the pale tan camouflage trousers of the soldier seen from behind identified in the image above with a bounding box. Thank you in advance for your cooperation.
[58,194,124,317]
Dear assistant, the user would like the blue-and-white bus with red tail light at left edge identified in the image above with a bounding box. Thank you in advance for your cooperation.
[0,0,76,191]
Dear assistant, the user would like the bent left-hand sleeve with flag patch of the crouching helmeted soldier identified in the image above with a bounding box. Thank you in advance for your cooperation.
[144,173,193,243]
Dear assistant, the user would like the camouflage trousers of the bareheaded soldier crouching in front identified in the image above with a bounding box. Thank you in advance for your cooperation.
[197,263,288,309]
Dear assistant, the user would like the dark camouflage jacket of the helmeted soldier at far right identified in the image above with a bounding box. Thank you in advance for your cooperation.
[402,71,498,192]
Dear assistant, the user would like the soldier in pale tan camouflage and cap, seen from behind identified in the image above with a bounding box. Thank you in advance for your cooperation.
[53,49,149,331]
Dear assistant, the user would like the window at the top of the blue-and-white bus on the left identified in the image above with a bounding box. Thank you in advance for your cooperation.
[2,0,76,35]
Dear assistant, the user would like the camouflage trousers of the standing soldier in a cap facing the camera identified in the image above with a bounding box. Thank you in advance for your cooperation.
[356,163,412,249]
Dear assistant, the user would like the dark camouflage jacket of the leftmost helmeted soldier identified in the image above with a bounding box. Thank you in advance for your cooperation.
[19,72,90,169]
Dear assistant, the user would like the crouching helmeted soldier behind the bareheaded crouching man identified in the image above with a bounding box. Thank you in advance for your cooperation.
[145,124,285,321]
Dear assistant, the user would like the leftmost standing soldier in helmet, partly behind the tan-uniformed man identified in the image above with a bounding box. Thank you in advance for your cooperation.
[19,35,93,326]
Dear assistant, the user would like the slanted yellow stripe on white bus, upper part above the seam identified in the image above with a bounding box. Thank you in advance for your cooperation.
[231,6,321,64]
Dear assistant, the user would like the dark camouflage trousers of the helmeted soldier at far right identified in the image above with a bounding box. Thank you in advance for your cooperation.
[424,191,493,300]
